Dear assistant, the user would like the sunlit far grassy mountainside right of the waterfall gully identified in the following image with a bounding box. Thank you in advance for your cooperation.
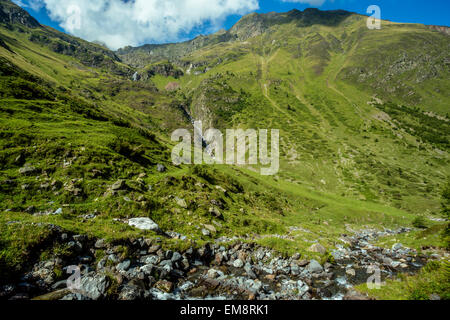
[124,10,450,213]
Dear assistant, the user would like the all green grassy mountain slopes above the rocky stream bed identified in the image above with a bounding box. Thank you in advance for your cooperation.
[0,0,450,300]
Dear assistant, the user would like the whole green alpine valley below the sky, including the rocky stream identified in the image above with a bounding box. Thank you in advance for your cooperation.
[0,0,450,300]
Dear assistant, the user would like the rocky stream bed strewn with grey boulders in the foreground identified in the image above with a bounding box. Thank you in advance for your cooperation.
[0,226,442,300]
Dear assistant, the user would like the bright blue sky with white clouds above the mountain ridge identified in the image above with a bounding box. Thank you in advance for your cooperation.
[15,0,450,49]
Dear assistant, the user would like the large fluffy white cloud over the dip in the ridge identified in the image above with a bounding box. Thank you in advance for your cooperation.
[20,0,259,49]
